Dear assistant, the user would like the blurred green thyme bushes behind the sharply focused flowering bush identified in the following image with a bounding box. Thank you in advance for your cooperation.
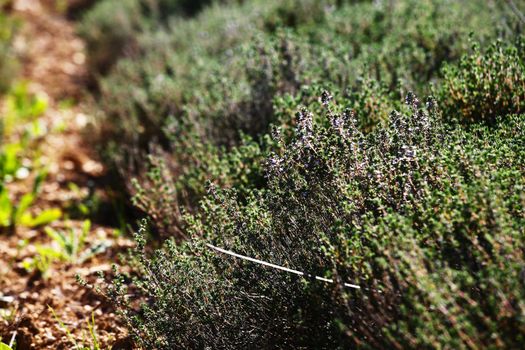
[86,0,521,236]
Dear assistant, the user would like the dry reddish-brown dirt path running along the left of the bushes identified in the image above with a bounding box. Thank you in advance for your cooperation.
[0,0,131,350]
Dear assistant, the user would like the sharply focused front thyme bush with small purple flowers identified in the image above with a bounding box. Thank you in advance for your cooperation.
[109,94,525,348]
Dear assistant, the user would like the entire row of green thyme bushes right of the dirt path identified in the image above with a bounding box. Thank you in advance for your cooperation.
[79,0,525,349]
